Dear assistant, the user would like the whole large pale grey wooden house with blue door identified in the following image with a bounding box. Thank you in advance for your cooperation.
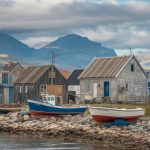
[79,55,148,103]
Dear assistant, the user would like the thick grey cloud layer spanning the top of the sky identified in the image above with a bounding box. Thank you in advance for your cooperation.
[0,0,150,32]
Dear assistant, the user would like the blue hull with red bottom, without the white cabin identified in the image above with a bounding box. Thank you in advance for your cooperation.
[28,100,86,115]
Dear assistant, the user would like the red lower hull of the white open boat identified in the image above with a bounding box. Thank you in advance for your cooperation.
[92,115,142,123]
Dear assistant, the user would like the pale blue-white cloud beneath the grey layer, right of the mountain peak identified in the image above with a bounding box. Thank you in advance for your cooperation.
[77,21,150,49]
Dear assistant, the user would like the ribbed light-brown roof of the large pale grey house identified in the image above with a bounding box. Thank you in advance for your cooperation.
[79,56,131,79]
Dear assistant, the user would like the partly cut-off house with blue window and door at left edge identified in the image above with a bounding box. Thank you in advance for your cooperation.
[0,62,24,104]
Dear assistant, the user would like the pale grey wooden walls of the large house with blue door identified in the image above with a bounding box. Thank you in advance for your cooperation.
[80,57,147,103]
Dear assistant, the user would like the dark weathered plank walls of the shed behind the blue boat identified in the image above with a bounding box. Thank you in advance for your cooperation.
[14,67,66,103]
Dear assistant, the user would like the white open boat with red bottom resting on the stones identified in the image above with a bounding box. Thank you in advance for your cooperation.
[89,106,145,123]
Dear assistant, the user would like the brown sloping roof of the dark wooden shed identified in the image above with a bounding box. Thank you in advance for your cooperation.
[15,65,51,83]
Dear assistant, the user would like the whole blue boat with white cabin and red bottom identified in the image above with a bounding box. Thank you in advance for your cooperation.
[28,95,86,115]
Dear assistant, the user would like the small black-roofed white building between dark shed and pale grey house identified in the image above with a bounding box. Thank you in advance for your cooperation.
[67,69,83,101]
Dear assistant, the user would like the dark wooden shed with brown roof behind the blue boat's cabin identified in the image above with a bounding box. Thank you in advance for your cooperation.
[14,65,66,103]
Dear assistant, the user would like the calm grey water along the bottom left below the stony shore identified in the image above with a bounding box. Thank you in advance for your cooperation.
[0,133,106,150]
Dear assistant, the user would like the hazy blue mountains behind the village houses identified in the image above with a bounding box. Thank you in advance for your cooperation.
[0,34,116,69]
